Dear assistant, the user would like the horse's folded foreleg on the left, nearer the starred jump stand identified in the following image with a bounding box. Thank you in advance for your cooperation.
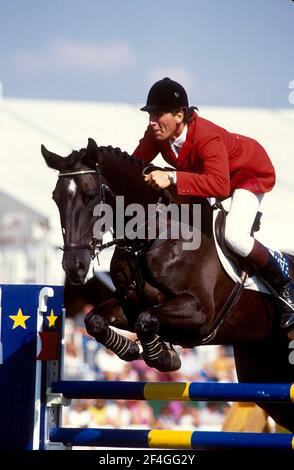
[85,299,139,362]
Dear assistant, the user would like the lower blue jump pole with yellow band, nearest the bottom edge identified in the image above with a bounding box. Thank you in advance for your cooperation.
[49,428,294,450]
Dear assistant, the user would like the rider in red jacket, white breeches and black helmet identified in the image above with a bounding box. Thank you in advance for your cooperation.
[134,77,294,334]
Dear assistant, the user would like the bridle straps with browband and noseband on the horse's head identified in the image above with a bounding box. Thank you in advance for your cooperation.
[58,163,171,262]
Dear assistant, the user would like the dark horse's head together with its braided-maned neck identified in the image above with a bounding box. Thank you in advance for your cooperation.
[41,139,173,284]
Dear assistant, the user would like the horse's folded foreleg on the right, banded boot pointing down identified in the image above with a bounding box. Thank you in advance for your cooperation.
[135,293,204,372]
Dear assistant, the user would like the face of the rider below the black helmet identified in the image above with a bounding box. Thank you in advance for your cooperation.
[149,111,185,141]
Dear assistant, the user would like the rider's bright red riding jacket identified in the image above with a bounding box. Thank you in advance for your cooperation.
[134,112,275,197]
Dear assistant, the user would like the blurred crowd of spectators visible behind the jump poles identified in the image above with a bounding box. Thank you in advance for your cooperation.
[63,318,236,431]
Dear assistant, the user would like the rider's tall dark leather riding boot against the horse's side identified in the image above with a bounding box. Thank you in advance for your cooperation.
[246,240,294,331]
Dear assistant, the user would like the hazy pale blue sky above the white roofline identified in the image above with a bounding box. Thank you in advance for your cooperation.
[0,0,294,108]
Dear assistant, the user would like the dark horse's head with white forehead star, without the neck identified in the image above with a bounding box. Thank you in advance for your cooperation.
[41,139,100,284]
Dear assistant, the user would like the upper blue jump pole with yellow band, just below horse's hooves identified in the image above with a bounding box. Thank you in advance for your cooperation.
[52,381,294,403]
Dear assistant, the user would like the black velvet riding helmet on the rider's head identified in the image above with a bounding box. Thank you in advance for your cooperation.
[141,77,189,112]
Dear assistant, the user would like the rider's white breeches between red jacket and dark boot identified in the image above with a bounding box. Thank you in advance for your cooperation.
[225,189,264,257]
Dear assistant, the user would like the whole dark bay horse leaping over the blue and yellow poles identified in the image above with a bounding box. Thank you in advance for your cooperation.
[42,139,294,432]
